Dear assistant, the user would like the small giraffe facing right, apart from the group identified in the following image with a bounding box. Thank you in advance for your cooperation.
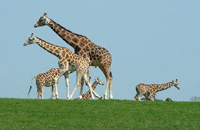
[135,79,180,101]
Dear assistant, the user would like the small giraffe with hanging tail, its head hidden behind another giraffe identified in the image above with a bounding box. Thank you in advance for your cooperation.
[28,68,60,99]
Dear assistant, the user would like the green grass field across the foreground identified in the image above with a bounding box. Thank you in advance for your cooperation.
[0,98,200,130]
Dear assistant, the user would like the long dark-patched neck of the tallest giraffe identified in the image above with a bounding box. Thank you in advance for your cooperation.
[49,19,86,49]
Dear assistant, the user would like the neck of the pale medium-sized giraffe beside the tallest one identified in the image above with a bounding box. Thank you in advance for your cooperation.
[36,37,62,58]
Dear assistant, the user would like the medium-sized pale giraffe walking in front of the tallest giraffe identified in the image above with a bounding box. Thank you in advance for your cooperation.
[24,33,101,99]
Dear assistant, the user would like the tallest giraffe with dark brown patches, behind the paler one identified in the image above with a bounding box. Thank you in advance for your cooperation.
[34,13,113,99]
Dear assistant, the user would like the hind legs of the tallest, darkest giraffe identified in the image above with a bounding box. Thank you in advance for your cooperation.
[99,64,113,99]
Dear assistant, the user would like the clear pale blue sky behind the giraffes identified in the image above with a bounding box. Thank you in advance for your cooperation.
[0,0,200,101]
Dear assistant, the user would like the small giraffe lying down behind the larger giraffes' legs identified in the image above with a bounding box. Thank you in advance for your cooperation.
[75,77,104,99]
